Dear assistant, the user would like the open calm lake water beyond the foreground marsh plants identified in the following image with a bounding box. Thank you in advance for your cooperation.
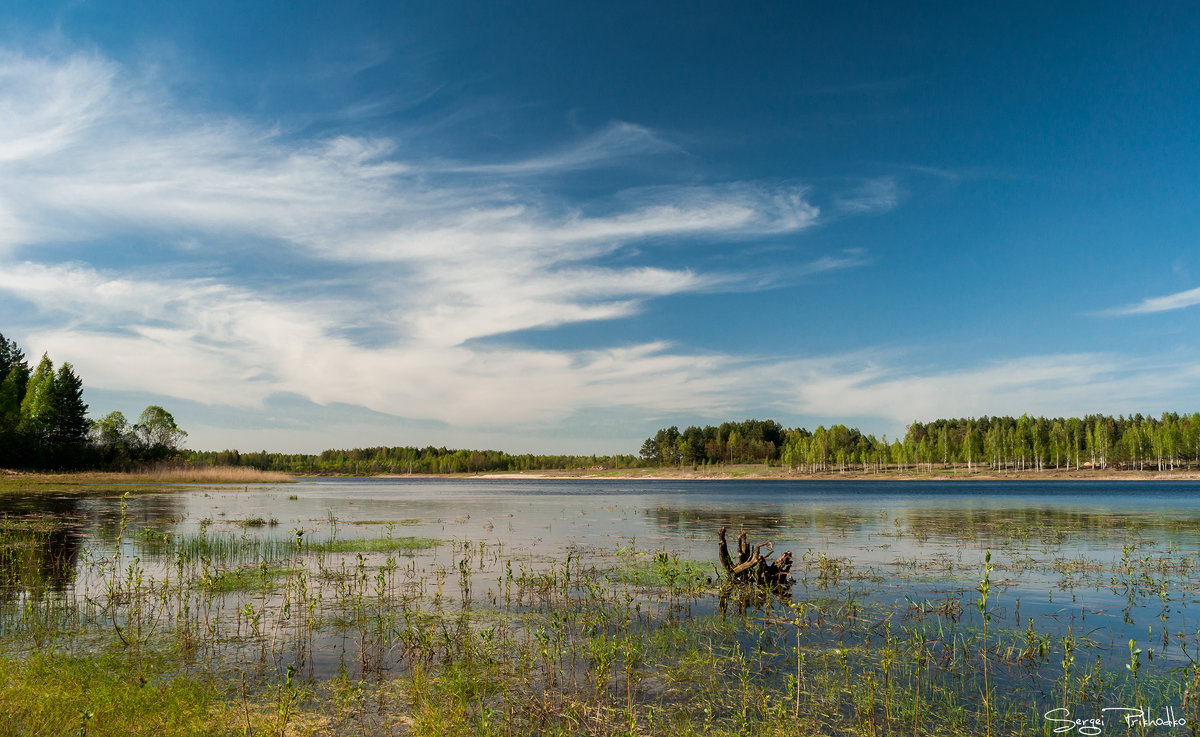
[0,478,1200,700]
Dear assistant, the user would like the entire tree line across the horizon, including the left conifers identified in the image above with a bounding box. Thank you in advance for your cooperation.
[7,324,1200,475]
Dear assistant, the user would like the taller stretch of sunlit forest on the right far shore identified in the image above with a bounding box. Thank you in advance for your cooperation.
[640,412,1200,473]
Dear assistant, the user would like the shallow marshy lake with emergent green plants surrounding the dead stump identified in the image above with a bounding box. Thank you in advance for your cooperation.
[0,481,1200,735]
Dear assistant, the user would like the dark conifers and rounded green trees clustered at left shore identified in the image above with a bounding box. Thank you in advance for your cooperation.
[0,334,187,471]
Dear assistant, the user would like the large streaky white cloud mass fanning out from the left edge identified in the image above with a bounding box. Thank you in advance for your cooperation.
[0,49,858,436]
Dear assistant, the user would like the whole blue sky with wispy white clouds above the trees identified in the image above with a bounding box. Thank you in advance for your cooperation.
[0,0,1200,453]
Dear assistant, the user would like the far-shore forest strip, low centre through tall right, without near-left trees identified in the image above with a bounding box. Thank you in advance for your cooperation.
[186,413,1200,475]
